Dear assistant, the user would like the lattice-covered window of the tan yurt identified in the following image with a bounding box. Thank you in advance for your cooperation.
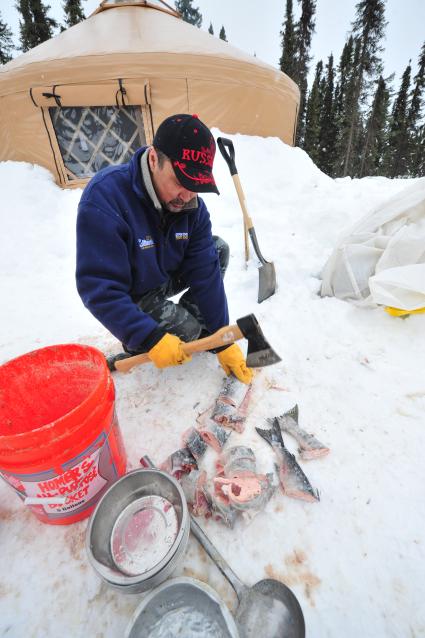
[49,106,146,179]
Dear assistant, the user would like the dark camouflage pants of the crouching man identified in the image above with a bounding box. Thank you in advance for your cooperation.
[126,235,229,352]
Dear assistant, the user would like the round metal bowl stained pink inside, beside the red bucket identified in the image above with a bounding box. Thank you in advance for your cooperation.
[86,469,190,594]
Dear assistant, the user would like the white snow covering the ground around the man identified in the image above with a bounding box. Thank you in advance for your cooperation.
[0,131,425,638]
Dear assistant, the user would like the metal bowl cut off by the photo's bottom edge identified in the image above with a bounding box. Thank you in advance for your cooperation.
[125,577,239,638]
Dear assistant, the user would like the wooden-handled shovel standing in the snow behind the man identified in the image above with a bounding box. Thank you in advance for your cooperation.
[217,137,276,303]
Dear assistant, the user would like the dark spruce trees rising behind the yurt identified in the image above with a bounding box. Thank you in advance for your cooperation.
[0,0,425,177]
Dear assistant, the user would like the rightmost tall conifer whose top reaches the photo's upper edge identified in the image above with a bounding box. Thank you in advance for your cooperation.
[343,0,387,175]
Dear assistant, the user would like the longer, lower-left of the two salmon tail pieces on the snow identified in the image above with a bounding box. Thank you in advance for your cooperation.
[255,418,320,502]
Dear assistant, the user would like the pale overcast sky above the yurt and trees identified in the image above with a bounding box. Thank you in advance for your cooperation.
[0,0,425,88]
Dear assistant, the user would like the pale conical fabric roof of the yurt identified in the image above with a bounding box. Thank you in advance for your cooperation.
[0,0,298,95]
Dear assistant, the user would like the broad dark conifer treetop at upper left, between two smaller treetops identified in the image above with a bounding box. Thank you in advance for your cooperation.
[16,0,58,51]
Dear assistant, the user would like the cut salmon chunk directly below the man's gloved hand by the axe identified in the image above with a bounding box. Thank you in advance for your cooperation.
[211,374,252,432]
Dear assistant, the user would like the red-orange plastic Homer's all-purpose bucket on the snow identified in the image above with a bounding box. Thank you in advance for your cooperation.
[0,344,126,525]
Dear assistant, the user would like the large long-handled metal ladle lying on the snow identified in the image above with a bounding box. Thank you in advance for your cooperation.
[140,455,305,638]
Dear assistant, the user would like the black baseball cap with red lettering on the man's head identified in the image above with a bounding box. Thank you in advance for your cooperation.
[153,113,220,195]
